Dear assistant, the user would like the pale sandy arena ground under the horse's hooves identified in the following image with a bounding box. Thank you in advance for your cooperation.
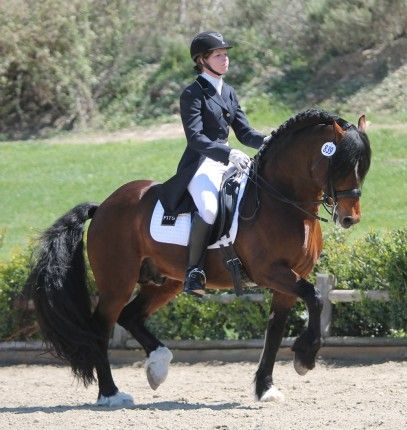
[0,362,407,430]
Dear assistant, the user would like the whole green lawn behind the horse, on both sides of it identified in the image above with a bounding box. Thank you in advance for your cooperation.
[0,127,407,260]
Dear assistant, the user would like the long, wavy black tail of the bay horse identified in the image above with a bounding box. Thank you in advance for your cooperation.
[27,203,101,386]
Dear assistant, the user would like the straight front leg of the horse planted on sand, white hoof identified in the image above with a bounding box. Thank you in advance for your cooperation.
[255,291,297,402]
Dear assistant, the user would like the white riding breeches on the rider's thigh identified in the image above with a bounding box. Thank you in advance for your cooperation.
[188,158,233,224]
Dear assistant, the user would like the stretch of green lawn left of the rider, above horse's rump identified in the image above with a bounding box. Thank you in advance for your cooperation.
[0,141,184,260]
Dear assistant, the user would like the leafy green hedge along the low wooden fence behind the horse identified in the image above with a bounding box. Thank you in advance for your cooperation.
[0,229,407,340]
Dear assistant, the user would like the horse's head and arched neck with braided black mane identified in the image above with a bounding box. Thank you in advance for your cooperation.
[258,109,371,228]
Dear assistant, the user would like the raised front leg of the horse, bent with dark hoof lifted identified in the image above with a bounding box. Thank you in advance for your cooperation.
[292,279,322,375]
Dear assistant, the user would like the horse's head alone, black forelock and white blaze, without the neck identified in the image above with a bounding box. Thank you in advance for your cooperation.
[321,115,371,228]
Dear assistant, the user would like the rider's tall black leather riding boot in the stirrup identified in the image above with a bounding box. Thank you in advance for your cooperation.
[184,213,213,297]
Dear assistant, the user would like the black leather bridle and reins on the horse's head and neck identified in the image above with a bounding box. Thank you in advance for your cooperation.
[239,150,362,222]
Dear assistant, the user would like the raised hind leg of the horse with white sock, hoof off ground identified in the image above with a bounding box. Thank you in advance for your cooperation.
[117,279,182,390]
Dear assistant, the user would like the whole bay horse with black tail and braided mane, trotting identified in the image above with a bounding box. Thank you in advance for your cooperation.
[27,109,371,406]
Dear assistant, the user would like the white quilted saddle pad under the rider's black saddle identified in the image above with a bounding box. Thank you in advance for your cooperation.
[150,175,247,249]
